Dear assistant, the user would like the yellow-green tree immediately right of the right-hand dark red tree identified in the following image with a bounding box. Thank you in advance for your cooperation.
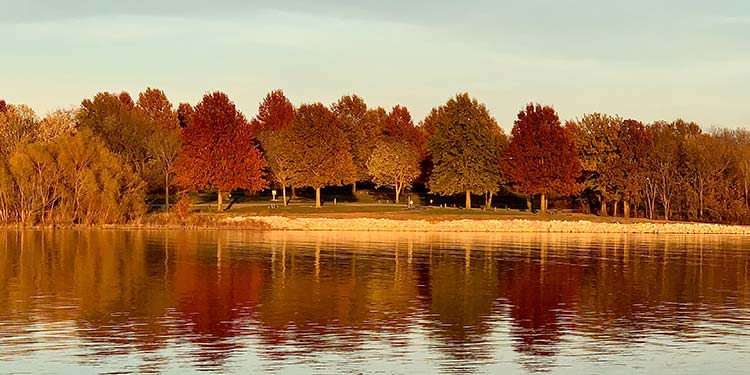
[566,113,622,216]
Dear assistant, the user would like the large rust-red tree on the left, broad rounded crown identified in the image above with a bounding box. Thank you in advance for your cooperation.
[174,92,265,211]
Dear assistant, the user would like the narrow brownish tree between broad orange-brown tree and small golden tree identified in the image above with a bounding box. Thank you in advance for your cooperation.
[331,95,377,193]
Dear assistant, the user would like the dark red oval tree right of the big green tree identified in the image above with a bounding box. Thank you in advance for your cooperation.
[503,104,581,212]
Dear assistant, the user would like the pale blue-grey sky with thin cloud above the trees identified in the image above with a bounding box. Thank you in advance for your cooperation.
[0,0,750,131]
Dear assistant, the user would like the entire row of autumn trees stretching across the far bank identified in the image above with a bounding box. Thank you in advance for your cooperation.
[0,88,750,224]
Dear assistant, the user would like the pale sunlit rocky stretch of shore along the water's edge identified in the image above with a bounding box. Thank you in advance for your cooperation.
[222,216,750,235]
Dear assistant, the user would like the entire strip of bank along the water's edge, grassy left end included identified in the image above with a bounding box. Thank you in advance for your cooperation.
[0,215,750,235]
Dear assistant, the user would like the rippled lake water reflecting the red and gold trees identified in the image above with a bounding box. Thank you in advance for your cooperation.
[0,230,750,374]
